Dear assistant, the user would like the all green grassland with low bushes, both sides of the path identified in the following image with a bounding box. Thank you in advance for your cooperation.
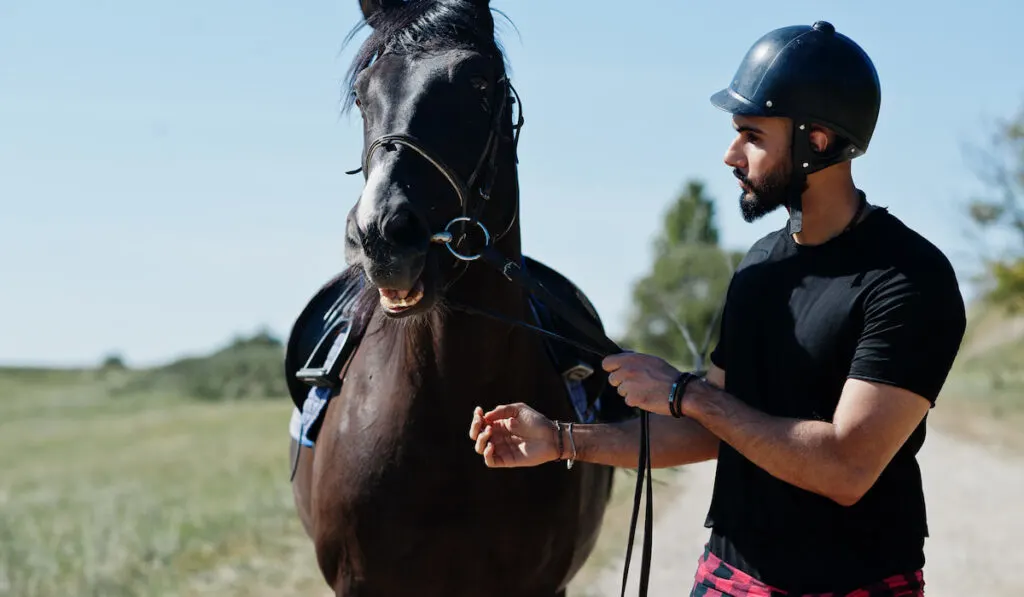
[0,301,1024,597]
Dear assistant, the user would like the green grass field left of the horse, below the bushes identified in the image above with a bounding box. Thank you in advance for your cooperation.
[0,366,323,597]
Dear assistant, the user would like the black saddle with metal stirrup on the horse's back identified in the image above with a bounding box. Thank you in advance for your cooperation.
[285,256,636,441]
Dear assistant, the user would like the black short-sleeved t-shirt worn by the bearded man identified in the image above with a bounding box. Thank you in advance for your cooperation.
[706,208,966,592]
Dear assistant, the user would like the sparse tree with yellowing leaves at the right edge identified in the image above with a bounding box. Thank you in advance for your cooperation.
[968,100,1024,311]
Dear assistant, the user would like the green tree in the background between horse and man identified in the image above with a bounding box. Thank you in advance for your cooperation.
[625,180,742,369]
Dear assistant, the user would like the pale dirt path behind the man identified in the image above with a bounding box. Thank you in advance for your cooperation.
[583,427,1024,597]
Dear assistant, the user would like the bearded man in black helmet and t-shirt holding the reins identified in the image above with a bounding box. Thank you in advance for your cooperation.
[470,22,966,596]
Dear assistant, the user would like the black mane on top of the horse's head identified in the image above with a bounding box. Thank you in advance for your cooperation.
[343,0,514,111]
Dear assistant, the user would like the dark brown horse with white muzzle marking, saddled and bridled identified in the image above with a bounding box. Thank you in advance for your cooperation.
[286,0,634,597]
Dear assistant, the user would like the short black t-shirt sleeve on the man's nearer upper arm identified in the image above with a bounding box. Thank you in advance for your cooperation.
[849,275,967,407]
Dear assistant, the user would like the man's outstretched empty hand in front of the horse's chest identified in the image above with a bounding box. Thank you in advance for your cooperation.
[469,402,561,468]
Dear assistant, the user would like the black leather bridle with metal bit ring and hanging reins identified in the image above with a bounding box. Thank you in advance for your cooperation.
[346,64,653,597]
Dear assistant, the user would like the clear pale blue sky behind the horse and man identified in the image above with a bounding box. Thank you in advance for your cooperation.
[0,0,1024,366]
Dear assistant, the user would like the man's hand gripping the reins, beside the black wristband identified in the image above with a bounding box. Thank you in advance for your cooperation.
[601,352,681,416]
